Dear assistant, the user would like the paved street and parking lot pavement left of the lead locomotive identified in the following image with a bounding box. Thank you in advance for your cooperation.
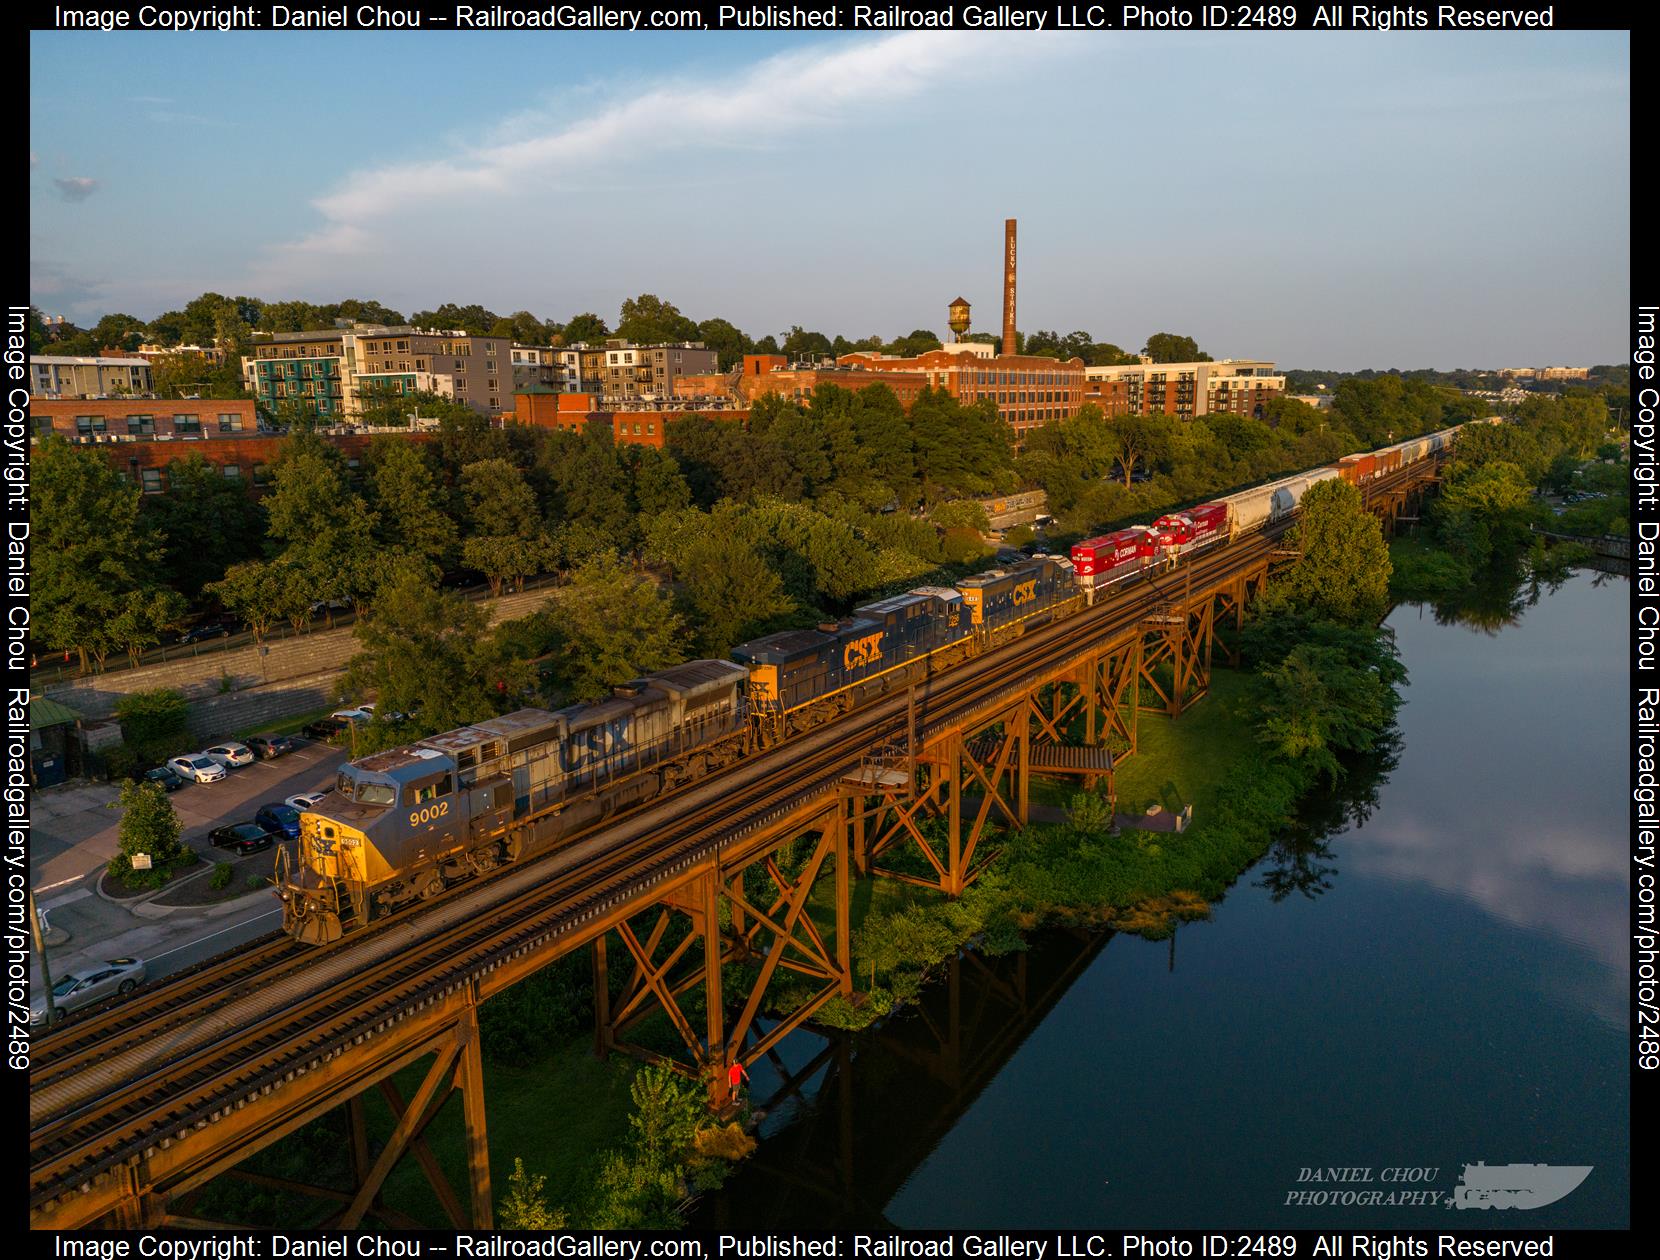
[30,744,345,978]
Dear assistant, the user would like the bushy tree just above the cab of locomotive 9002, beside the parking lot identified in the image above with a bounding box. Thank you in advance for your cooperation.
[344,563,530,730]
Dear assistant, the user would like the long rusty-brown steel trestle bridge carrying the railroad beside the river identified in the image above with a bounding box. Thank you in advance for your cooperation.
[30,460,1438,1228]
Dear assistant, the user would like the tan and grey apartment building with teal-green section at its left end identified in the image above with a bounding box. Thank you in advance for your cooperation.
[242,324,513,420]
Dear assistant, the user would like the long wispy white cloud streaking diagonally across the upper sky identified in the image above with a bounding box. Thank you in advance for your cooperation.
[245,32,1075,291]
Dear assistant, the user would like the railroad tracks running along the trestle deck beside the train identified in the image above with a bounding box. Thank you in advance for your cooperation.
[30,524,1273,1205]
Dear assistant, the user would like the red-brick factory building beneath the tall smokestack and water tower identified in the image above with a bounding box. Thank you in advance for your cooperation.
[837,342,1084,442]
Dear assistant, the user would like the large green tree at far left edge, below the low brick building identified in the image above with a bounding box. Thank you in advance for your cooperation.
[30,437,161,669]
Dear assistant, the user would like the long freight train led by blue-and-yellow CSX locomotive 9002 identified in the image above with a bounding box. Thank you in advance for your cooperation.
[276,428,1480,945]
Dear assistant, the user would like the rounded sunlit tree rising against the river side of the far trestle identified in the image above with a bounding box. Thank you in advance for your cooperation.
[1270,478,1389,626]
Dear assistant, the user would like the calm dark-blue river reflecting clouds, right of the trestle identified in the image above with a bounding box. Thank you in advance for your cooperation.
[694,573,1630,1230]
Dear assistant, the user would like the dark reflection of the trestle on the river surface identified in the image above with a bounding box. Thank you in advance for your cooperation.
[692,928,1112,1232]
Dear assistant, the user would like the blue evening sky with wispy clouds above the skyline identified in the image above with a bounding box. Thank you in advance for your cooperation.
[30,32,1630,370]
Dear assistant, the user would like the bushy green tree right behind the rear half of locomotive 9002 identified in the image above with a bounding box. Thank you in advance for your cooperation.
[548,554,686,701]
